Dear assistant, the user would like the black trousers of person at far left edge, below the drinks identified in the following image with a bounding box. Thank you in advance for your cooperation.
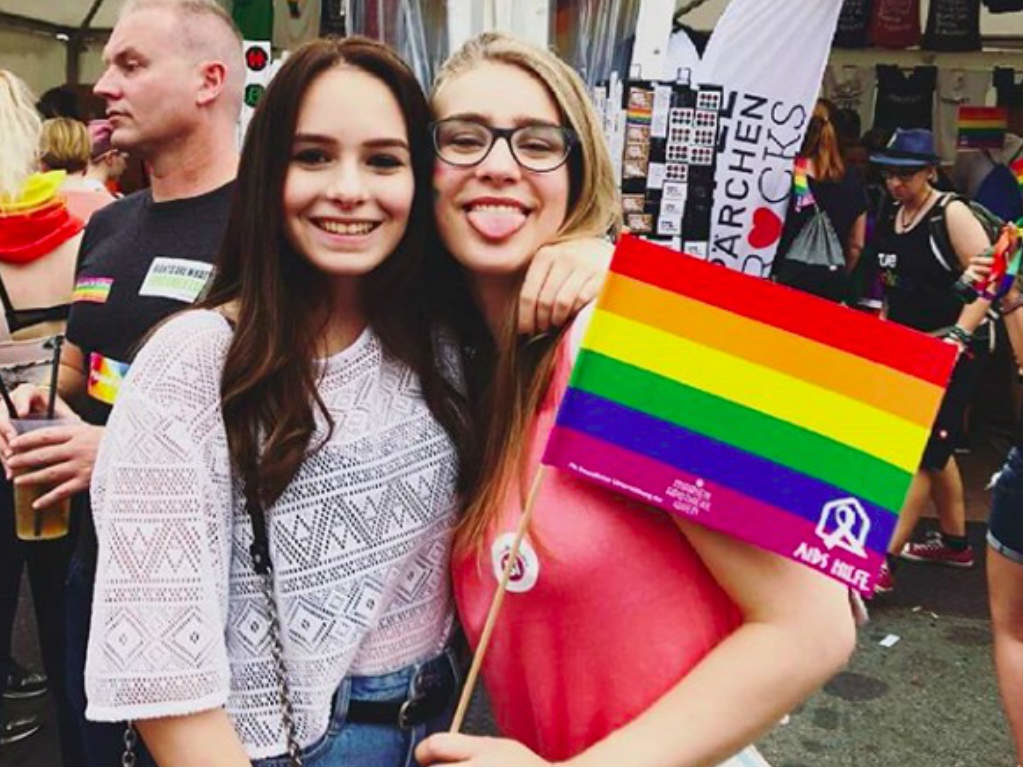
[0,475,82,765]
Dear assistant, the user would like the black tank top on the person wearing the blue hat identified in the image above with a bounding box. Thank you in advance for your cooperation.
[874,196,964,332]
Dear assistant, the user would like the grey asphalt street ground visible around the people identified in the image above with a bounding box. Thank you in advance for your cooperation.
[0,423,1013,766]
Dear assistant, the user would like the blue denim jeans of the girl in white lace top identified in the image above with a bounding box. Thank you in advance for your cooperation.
[253,649,462,766]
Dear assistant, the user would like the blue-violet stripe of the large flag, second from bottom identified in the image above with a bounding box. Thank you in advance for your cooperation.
[558,387,895,552]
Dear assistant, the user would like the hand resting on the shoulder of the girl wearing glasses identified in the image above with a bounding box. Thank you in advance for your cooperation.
[519,238,614,335]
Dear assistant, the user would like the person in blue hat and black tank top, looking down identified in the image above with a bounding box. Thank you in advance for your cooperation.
[870,128,990,592]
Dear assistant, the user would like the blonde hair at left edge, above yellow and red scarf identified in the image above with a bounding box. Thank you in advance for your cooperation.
[0,70,42,200]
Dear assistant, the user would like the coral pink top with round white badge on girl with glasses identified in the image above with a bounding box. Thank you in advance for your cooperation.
[453,329,740,760]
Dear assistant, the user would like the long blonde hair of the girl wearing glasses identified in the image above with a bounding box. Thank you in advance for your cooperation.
[431,32,622,552]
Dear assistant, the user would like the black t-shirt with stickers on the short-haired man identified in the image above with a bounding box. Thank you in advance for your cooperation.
[68,182,233,425]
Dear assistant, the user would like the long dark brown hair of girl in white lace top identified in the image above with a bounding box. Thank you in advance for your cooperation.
[200,37,471,512]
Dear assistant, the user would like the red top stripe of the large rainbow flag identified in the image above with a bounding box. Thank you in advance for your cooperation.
[611,234,955,387]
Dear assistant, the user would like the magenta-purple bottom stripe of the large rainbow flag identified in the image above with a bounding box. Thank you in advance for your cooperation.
[544,427,895,594]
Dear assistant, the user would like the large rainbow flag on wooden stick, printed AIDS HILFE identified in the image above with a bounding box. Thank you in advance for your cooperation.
[544,236,955,593]
